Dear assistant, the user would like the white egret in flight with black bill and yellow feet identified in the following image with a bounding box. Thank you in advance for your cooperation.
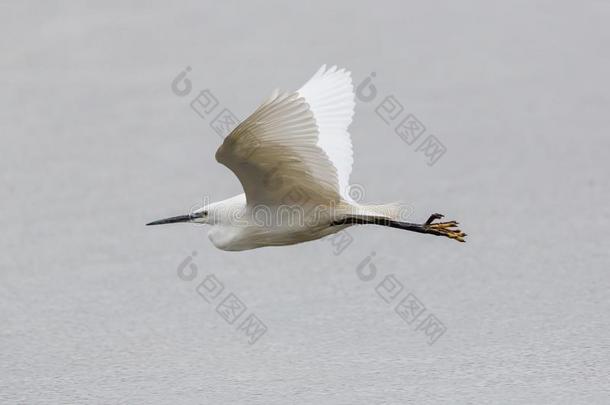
[147,65,466,251]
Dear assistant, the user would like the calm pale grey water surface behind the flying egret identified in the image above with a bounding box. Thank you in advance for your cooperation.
[0,1,610,404]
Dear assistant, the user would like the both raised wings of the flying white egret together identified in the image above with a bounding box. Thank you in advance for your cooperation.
[216,66,354,206]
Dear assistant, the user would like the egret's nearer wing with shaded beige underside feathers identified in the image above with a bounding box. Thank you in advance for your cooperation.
[216,91,340,206]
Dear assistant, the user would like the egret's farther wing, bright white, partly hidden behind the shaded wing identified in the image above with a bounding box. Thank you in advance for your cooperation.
[298,65,355,201]
